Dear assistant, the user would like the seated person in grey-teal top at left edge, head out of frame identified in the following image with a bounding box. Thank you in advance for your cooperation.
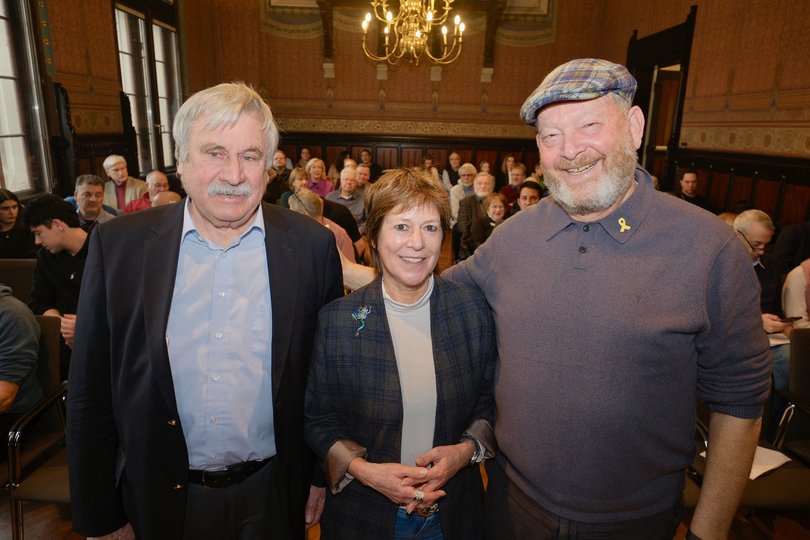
[0,283,42,438]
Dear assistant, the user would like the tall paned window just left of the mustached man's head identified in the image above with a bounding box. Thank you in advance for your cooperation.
[115,4,181,174]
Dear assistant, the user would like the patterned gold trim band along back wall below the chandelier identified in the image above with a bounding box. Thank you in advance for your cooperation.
[277,118,534,141]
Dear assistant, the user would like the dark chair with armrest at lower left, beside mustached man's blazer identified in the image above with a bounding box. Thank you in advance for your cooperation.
[8,316,70,540]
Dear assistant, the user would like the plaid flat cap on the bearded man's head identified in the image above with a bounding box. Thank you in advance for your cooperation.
[520,58,637,126]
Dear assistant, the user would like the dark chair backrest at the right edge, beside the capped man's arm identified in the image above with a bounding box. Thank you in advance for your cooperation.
[774,328,810,465]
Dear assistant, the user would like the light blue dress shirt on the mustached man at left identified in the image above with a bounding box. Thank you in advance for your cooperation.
[166,201,276,470]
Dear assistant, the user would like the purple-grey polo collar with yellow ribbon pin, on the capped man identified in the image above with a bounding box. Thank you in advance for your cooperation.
[546,166,655,244]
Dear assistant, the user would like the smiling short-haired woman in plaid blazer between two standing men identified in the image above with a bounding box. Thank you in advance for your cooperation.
[305,169,497,540]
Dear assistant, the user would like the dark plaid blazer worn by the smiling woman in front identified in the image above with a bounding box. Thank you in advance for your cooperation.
[305,277,497,540]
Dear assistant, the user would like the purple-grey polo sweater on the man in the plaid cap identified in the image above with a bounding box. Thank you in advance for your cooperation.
[445,169,771,522]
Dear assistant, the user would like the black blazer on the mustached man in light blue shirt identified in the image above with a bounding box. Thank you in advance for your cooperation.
[67,204,342,540]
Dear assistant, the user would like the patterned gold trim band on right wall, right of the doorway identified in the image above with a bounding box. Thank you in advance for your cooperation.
[681,125,810,158]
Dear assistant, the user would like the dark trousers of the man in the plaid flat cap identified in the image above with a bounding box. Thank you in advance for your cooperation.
[485,460,684,540]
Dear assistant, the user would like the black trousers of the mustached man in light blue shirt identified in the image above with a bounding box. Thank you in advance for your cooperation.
[183,459,288,540]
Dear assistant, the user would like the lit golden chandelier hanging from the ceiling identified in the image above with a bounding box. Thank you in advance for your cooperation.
[362,0,464,65]
